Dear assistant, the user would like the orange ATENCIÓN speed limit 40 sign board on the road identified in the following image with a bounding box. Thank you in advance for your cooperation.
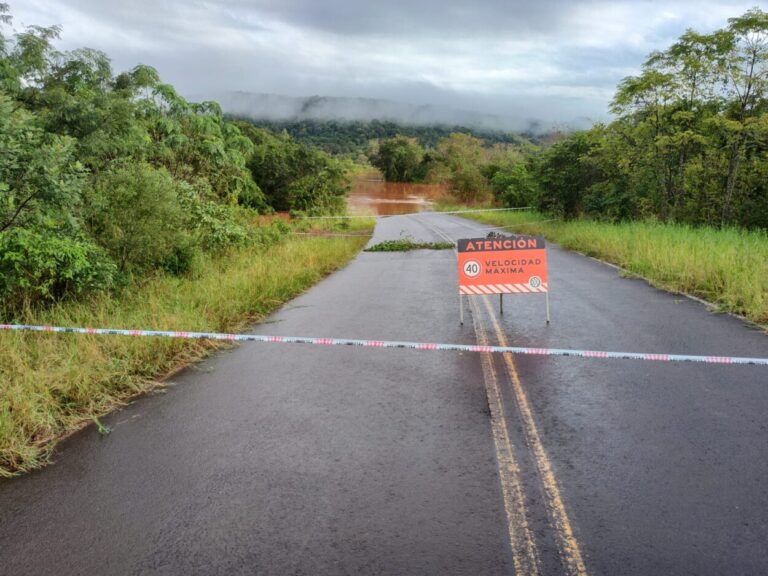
[458,236,548,294]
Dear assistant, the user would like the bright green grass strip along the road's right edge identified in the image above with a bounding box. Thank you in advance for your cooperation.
[460,212,768,327]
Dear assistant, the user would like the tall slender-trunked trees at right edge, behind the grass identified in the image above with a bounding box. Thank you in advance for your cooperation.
[585,8,768,225]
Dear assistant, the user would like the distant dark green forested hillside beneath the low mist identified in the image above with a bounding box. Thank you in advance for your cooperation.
[230,118,526,159]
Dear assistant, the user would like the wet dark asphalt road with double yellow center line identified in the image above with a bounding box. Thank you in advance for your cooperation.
[0,215,768,575]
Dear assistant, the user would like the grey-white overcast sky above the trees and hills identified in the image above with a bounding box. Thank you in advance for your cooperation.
[5,0,756,123]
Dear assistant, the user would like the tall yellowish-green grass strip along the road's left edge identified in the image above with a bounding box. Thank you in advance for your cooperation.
[0,232,366,476]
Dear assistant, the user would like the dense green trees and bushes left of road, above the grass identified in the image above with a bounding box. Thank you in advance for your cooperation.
[0,3,346,311]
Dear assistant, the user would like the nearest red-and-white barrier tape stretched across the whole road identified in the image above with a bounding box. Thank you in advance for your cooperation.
[0,324,768,366]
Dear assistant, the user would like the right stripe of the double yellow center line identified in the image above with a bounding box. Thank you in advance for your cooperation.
[483,296,587,576]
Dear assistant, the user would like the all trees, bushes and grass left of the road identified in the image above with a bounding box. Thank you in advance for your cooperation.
[0,9,370,476]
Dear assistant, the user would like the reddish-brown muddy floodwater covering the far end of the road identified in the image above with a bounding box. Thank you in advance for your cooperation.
[347,172,446,216]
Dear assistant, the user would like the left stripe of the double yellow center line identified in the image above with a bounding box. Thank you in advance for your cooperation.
[470,300,540,576]
